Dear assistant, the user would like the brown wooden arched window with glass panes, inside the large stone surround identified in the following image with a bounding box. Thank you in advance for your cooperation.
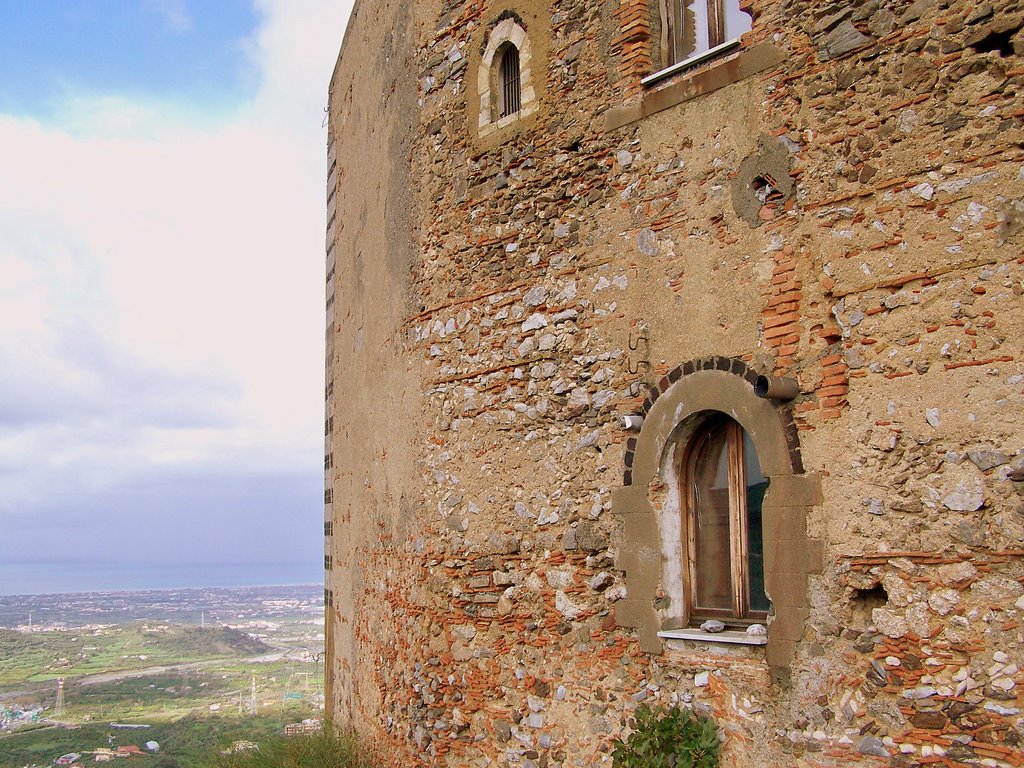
[679,415,769,624]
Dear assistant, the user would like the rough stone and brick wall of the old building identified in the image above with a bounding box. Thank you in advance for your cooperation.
[325,0,1024,768]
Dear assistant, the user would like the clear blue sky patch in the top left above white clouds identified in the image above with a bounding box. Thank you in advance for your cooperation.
[0,0,260,118]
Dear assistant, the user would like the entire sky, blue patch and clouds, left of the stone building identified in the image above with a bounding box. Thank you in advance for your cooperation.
[0,0,350,594]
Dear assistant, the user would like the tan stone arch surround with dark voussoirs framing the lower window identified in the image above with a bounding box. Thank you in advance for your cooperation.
[612,356,821,677]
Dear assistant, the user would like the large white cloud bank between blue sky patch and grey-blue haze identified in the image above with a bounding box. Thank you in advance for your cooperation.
[0,0,350,529]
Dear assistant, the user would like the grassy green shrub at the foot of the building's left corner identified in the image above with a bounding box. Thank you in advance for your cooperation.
[208,726,373,768]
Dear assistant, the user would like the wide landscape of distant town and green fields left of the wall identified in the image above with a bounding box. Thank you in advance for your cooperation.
[0,585,324,768]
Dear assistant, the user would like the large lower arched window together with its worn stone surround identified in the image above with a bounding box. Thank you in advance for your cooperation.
[611,355,824,681]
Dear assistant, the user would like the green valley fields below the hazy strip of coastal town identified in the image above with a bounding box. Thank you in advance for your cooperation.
[0,588,323,768]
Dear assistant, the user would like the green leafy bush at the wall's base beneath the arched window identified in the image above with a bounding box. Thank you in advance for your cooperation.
[611,705,721,768]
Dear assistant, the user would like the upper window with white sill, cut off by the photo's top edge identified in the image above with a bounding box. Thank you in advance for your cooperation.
[658,0,752,69]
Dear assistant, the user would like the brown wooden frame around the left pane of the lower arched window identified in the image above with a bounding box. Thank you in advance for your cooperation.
[679,414,768,627]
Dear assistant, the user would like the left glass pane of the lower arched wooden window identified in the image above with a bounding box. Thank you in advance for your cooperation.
[691,424,733,610]
